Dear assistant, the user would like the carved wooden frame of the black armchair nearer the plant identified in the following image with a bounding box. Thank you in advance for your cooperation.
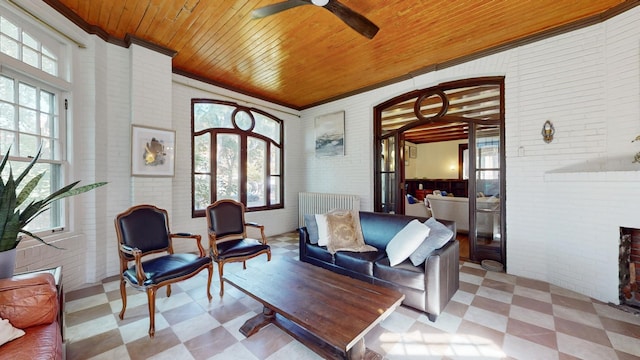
[115,204,213,337]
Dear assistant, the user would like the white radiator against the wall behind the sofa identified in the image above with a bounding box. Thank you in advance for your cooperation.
[298,192,360,227]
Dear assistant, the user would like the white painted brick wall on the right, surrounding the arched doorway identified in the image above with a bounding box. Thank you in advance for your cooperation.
[303,8,640,302]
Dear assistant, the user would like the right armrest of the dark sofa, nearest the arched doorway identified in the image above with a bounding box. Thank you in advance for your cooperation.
[424,239,460,321]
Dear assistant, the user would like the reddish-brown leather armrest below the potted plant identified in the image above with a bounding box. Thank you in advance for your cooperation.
[0,273,59,329]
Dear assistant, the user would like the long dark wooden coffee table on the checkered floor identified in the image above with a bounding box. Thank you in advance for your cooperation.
[224,258,404,359]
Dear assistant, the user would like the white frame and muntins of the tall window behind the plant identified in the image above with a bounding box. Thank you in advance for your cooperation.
[0,11,71,240]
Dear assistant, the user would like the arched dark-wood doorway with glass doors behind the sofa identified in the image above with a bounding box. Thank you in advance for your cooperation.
[374,77,506,264]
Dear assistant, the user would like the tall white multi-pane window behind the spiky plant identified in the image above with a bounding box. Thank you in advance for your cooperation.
[0,14,68,236]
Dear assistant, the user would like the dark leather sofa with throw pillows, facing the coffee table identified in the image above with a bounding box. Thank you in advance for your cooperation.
[299,211,460,321]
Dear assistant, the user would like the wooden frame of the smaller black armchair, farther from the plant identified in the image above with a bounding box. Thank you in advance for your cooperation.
[206,199,271,297]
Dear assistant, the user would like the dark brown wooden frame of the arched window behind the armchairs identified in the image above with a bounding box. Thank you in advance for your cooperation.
[191,98,284,218]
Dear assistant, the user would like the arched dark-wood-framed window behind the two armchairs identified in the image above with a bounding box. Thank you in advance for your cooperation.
[191,99,284,217]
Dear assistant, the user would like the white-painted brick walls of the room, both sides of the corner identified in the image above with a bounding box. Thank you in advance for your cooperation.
[8,1,640,302]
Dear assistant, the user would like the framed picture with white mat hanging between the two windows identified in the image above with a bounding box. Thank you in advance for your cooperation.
[131,125,176,176]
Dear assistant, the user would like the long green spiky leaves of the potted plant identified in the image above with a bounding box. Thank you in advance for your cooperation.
[0,149,106,251]
